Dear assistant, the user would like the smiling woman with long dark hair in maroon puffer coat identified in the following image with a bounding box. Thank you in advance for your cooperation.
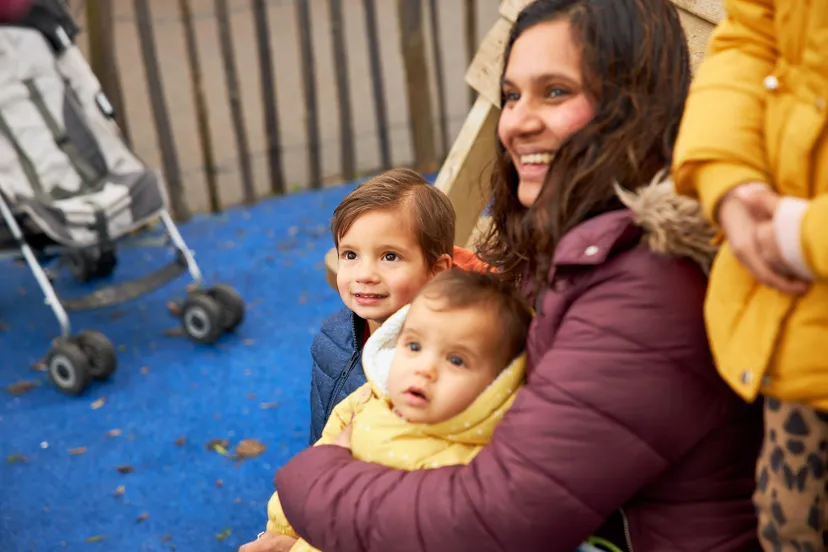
[276,0,762,552]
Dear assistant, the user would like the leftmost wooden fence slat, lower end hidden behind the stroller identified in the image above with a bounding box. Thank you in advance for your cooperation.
[86,0,132,145]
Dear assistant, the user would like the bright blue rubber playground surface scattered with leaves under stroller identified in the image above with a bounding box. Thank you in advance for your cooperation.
[0,185,360,552]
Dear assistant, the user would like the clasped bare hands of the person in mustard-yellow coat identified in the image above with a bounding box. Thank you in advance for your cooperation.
[718,182,808,295]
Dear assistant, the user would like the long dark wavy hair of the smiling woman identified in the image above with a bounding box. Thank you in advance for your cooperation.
[480,0,691,294]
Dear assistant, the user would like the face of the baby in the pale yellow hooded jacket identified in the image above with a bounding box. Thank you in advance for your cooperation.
[388,296,508,424]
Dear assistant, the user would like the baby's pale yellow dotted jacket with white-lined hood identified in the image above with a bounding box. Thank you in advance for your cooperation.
[267,306,526,552]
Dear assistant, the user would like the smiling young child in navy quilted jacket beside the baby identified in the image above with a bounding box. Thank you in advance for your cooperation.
[310,169,485,444]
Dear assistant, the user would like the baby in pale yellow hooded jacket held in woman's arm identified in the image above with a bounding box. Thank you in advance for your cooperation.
[267,269,532,552]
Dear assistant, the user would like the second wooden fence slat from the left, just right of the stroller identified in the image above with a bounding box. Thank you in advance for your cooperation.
[133,0,191,221]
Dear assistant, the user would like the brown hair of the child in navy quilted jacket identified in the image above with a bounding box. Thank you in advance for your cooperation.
[331,169,456,266]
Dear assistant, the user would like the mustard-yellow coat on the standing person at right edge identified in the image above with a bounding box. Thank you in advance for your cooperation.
[674,0,828,410]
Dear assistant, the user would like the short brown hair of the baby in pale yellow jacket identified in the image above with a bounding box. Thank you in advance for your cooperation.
[414,268,532,368]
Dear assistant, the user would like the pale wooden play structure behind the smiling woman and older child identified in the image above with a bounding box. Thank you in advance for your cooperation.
[325,0,724,289]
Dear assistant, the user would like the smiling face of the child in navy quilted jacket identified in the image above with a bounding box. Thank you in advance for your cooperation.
[336,209,434,331]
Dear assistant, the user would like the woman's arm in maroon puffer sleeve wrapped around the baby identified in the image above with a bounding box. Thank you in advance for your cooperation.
[276,253,722,552]
